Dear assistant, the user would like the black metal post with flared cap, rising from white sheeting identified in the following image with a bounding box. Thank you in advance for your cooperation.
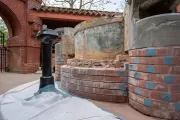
[36,25,58,89]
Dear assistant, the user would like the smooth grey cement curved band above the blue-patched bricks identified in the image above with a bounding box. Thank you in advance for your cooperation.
[129,13,180,49]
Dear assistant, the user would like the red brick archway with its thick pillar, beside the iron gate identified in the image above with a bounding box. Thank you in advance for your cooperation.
[0,0,41,73]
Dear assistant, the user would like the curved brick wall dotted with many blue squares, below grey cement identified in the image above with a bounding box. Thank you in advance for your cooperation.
[128,47,180,120]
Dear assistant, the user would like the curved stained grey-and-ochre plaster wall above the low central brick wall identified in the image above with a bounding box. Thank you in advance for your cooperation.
[75,16,124,60]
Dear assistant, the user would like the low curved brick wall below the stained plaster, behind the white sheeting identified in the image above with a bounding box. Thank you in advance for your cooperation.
[61,65,128,102]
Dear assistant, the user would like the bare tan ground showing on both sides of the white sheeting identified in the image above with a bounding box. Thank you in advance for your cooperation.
[0,73,157,120]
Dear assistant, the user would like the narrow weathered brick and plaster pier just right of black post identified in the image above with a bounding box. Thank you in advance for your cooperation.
[55,27,75,81]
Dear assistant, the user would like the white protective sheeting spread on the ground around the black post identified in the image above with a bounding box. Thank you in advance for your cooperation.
[0,80,119,120]
